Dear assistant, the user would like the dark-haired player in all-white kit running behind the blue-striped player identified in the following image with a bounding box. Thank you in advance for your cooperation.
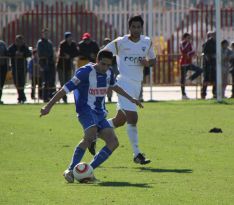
[104,15,156,164]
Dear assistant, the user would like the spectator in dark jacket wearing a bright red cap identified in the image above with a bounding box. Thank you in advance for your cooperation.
[78,33,99,67]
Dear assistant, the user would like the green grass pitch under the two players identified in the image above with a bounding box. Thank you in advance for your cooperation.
[0,100,234,205]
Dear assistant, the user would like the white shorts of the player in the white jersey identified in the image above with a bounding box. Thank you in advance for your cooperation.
[116,75,141,112]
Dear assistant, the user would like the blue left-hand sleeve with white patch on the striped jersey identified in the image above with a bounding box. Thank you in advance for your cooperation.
[63,68,89,93]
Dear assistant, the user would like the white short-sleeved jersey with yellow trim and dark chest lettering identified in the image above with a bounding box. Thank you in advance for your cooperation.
[104,35,155,81]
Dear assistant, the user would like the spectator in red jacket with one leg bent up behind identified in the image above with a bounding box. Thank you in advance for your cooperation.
[180,33,202,99]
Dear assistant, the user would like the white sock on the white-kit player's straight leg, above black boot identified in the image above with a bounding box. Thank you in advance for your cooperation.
[127,124,140,157]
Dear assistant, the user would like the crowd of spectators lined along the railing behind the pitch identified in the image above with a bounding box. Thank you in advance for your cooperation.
[0,24,234,104]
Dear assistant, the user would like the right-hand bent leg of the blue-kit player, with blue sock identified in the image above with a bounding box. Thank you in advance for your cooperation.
[90,128,119,169]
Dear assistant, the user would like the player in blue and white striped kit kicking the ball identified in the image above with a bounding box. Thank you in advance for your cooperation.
[41,50,143,183]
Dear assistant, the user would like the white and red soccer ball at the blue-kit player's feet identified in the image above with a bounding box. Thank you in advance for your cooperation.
[73,162,94,183]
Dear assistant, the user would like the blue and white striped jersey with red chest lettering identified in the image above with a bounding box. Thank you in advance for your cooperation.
[63,63,115,114]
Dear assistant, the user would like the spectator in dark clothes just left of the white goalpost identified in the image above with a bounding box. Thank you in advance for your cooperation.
[201,31,216,99]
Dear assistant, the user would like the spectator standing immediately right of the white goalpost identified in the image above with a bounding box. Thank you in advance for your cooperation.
[221,40,232,97]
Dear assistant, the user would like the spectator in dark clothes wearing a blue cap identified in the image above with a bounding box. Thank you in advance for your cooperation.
[57,32,78,103]
